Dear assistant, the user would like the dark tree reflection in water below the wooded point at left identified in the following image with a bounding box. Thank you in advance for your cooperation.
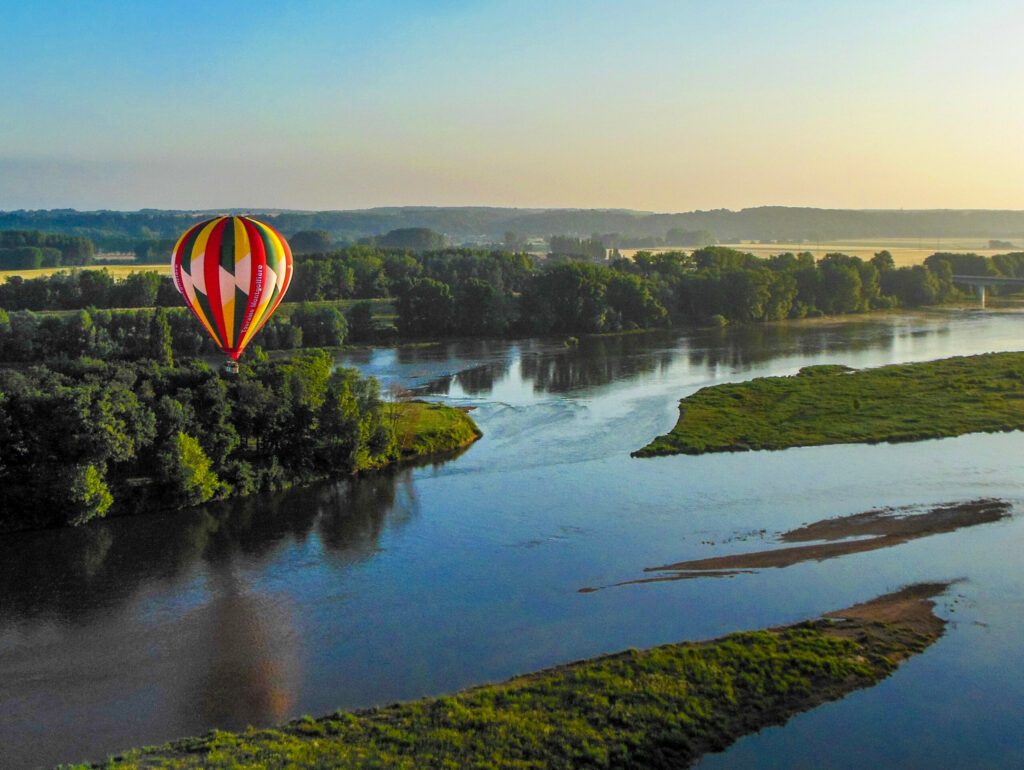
[0,469,417,626]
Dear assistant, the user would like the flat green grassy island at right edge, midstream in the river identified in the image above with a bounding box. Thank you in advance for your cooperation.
[633,352,1024,457]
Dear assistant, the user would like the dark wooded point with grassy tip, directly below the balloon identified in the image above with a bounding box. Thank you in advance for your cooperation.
[0,350,479,531]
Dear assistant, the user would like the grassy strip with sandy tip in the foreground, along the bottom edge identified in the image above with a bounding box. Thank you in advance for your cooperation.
[68,584,946,768]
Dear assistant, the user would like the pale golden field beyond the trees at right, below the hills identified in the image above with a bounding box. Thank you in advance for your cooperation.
[618,237,1024,267]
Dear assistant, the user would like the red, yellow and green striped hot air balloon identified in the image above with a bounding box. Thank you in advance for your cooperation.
[171,216,292,371]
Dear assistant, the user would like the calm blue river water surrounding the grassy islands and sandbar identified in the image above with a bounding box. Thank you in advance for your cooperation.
[0,312,1024,768]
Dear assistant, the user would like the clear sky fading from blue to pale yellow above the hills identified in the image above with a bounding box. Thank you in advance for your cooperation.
[0,0,1024,212]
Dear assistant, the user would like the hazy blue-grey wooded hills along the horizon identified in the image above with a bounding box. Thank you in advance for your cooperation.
[0,206,1024,249]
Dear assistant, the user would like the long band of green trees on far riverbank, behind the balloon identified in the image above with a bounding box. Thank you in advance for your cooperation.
[0,245,1024,341]
